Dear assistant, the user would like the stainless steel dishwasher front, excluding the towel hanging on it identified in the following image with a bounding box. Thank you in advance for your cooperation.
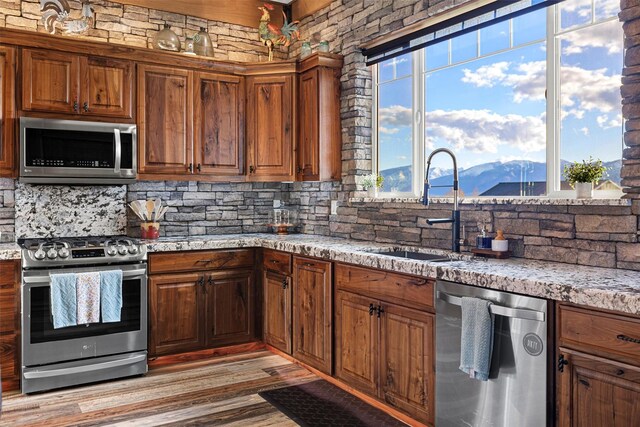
[435,281,552,427]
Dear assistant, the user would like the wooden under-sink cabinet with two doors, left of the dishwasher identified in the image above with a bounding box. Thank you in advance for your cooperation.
[334,264,435,424]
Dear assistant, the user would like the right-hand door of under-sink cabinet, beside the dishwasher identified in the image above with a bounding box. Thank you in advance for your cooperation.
[380,303,435,424]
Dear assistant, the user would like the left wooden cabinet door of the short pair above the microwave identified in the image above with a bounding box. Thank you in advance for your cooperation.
[22,49,80,114]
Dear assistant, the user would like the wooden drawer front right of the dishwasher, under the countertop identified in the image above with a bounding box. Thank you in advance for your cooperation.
[559,305,640,361]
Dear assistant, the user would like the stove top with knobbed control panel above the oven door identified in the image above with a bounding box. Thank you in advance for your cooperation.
[18,236,147,268]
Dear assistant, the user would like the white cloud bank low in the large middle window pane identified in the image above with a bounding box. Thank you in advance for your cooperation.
[427,110,546,153]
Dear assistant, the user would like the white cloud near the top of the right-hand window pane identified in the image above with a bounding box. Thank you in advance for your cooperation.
[562,20,622,55]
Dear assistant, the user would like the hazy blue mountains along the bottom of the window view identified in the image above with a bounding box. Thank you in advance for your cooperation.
[380,160,622,196]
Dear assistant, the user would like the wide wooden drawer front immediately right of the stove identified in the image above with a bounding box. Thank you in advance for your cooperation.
[149,249,253,274]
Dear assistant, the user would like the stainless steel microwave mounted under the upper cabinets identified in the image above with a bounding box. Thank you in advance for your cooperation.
[20,117,137,185]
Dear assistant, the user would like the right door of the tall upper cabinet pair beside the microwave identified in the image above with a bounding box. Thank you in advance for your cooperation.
[193,73,244,176]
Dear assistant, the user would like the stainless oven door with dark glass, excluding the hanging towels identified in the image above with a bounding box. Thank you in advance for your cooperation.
[22,263,147,367]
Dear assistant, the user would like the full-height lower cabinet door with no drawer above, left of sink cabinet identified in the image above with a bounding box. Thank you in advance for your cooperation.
[293,257,333,375]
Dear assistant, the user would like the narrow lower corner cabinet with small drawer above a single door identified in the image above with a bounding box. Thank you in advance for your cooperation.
[262,249,293,354]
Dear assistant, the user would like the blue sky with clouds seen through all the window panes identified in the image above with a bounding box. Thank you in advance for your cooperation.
[379,0,622,187]
